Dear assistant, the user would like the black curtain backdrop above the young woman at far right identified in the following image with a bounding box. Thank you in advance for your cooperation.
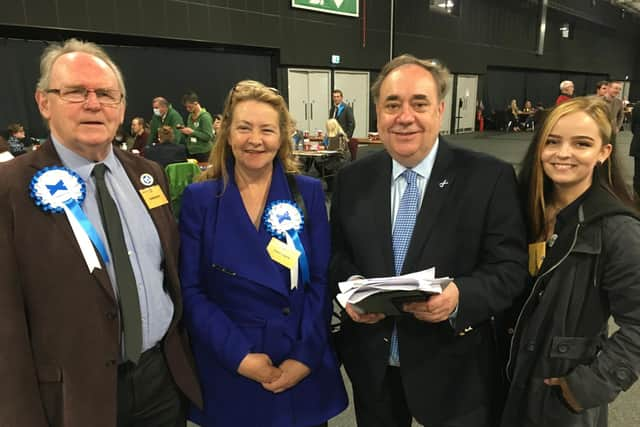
[482,68,608,115]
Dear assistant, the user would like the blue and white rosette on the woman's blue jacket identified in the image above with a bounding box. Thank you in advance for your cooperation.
[264,200,310,289]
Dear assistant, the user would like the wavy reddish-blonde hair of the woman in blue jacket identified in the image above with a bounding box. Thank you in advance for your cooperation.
[198,80,298,187]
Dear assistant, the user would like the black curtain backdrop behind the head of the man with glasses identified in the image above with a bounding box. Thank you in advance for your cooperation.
[0,39,276,138]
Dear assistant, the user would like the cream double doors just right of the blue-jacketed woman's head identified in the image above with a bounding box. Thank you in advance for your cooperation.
[288,69,331,131]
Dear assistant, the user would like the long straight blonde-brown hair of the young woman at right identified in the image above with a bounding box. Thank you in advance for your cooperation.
[520,97,633,240]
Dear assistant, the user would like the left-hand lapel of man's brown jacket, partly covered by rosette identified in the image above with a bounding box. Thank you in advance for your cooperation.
[31,141,116,302]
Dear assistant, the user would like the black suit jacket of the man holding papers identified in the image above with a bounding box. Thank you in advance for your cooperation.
[329,138,526,425]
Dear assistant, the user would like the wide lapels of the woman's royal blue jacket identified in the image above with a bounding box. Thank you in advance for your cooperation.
[211,161,291,296]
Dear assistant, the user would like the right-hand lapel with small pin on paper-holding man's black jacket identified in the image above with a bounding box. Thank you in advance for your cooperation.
[402,138,456,273]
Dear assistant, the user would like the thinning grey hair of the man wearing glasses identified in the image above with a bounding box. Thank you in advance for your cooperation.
[36,38,127,100]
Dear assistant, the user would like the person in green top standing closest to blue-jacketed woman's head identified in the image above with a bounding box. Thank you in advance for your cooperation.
[180,92,213,162]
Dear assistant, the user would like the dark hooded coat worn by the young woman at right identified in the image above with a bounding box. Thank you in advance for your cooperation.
[502,184,640,427]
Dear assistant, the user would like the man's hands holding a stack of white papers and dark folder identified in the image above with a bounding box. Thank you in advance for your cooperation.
[337,268,458,323]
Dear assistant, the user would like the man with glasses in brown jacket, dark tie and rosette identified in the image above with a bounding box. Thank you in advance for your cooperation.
[0,39,202,427]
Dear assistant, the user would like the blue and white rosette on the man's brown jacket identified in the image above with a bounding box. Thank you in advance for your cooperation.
[29,166,109,273]
